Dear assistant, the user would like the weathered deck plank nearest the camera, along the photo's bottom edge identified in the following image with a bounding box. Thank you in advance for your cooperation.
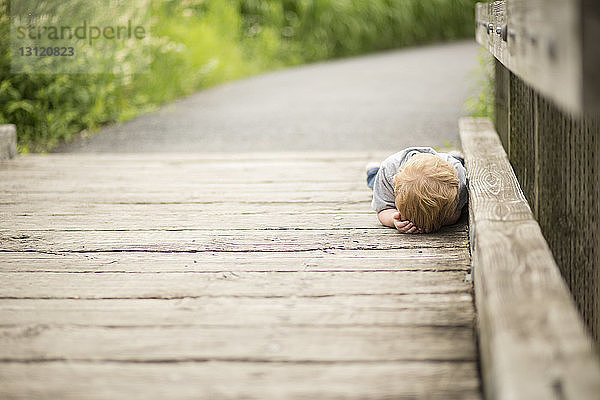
[0,361,480,400]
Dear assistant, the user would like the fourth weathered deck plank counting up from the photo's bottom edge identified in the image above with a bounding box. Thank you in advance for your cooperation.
[0,271,470,299]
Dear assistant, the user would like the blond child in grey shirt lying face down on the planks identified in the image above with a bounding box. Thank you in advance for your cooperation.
[367,147,468,233]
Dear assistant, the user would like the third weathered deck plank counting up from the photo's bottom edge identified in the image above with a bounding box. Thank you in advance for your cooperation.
[0,293,473,329]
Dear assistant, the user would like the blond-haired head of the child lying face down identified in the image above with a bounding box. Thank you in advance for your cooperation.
[394,153,458,232]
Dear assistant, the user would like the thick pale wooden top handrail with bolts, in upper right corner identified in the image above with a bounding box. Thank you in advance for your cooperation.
[476,0,600,114]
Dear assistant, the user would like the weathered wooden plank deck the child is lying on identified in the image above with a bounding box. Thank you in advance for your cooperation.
[0,152,481,399]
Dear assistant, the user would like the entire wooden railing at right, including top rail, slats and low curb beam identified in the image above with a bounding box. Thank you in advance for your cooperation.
[472,0,600,399]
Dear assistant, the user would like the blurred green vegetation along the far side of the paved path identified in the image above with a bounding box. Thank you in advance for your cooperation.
[0,0,476,152]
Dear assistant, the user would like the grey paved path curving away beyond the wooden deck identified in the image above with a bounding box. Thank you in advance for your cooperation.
[59,41,477,153]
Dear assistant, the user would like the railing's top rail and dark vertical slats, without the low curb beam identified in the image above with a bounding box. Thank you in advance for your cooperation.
[476,0,600,343]
